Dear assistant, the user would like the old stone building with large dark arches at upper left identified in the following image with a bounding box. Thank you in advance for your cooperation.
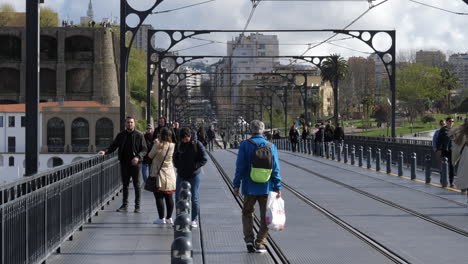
[0,27,119,106]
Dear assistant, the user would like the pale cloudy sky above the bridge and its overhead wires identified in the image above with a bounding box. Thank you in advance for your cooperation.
[4,0,468,60]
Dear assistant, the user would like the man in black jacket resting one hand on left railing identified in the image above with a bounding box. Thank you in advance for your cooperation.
[98,117,147,213]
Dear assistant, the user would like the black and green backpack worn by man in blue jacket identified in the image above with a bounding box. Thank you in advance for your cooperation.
[247,139,273,183]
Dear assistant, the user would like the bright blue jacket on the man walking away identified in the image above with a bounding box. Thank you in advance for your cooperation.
[233,135,281,195]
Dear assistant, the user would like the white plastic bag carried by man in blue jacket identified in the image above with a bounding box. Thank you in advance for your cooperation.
[265,192,286,231]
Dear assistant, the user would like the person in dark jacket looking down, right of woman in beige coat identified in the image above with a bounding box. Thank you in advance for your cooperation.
[174,127,208,228]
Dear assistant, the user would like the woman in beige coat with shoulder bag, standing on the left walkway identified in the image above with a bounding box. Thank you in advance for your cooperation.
[145,127,176,224]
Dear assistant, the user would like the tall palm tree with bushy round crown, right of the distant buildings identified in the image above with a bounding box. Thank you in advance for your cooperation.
[320,54,348,125]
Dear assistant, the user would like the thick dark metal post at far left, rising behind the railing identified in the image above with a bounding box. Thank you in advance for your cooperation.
[25,0,40,176]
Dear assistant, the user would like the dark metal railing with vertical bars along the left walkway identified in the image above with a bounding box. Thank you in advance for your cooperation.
[0,155,120,264]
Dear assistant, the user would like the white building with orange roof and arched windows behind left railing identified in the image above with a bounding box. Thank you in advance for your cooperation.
[0,101,119,184]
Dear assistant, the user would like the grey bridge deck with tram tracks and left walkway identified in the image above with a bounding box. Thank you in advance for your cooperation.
[47,150,468,264]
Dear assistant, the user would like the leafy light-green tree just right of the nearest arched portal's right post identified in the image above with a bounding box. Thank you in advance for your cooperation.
[397,63,446,131]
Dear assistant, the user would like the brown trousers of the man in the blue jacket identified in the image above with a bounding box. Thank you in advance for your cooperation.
[242,195,268,246]
